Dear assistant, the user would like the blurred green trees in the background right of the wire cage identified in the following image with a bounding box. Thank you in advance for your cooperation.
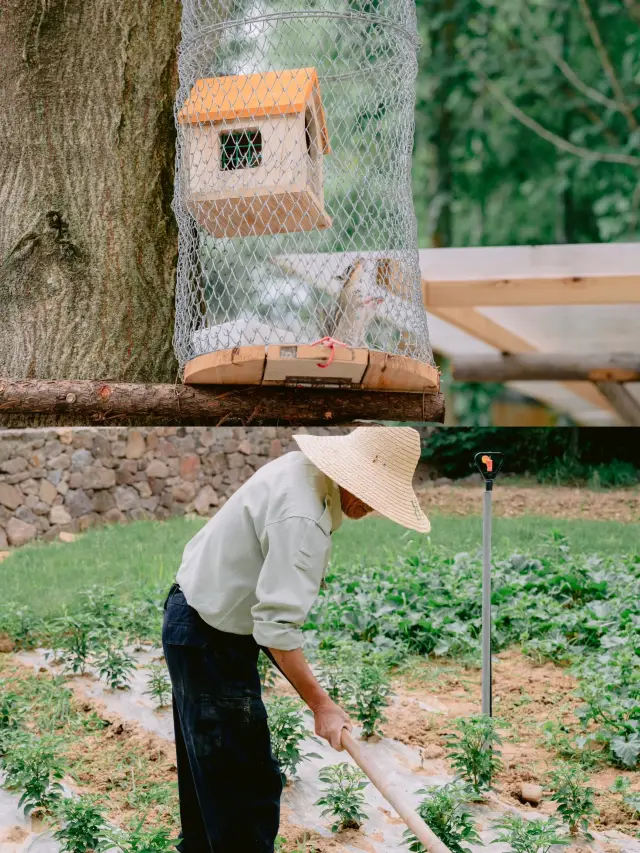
[413,0,640,426]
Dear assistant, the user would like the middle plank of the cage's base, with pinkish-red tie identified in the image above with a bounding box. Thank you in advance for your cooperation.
[263,344,369,385]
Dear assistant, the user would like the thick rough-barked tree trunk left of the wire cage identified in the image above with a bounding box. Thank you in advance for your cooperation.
[0,0,180,382]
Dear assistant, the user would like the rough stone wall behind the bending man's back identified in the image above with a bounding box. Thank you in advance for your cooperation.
[0,427,346,549]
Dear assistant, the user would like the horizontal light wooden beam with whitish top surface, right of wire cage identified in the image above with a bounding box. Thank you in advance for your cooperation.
[420,243,640,310]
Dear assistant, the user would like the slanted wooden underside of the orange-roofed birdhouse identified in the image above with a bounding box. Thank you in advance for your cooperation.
[187,188,332,237]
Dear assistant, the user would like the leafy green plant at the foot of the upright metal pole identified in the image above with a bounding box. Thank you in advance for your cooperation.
[446,715,502,795]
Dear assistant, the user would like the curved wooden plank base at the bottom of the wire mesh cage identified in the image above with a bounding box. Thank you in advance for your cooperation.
[184,344,440,394]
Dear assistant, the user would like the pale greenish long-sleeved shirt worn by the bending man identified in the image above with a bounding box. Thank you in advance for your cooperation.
[176,451,342,650]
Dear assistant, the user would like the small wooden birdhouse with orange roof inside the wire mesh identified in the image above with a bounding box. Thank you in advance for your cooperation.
[178,68,331,237]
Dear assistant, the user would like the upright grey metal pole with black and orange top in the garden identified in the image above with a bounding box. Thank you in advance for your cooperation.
[475,452,504,717]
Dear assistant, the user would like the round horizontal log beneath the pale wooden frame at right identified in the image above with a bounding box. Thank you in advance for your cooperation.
[453,352,640,382]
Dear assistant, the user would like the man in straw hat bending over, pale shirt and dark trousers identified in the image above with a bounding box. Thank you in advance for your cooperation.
[162,427,429,853]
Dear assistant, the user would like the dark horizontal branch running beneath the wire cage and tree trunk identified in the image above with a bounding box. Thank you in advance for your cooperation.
[0,378,445,427]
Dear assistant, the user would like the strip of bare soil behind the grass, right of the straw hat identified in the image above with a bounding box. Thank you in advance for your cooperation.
[417,481,640,522]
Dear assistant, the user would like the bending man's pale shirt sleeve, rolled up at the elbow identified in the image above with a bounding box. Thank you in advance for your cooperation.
[251,517,331,651]
